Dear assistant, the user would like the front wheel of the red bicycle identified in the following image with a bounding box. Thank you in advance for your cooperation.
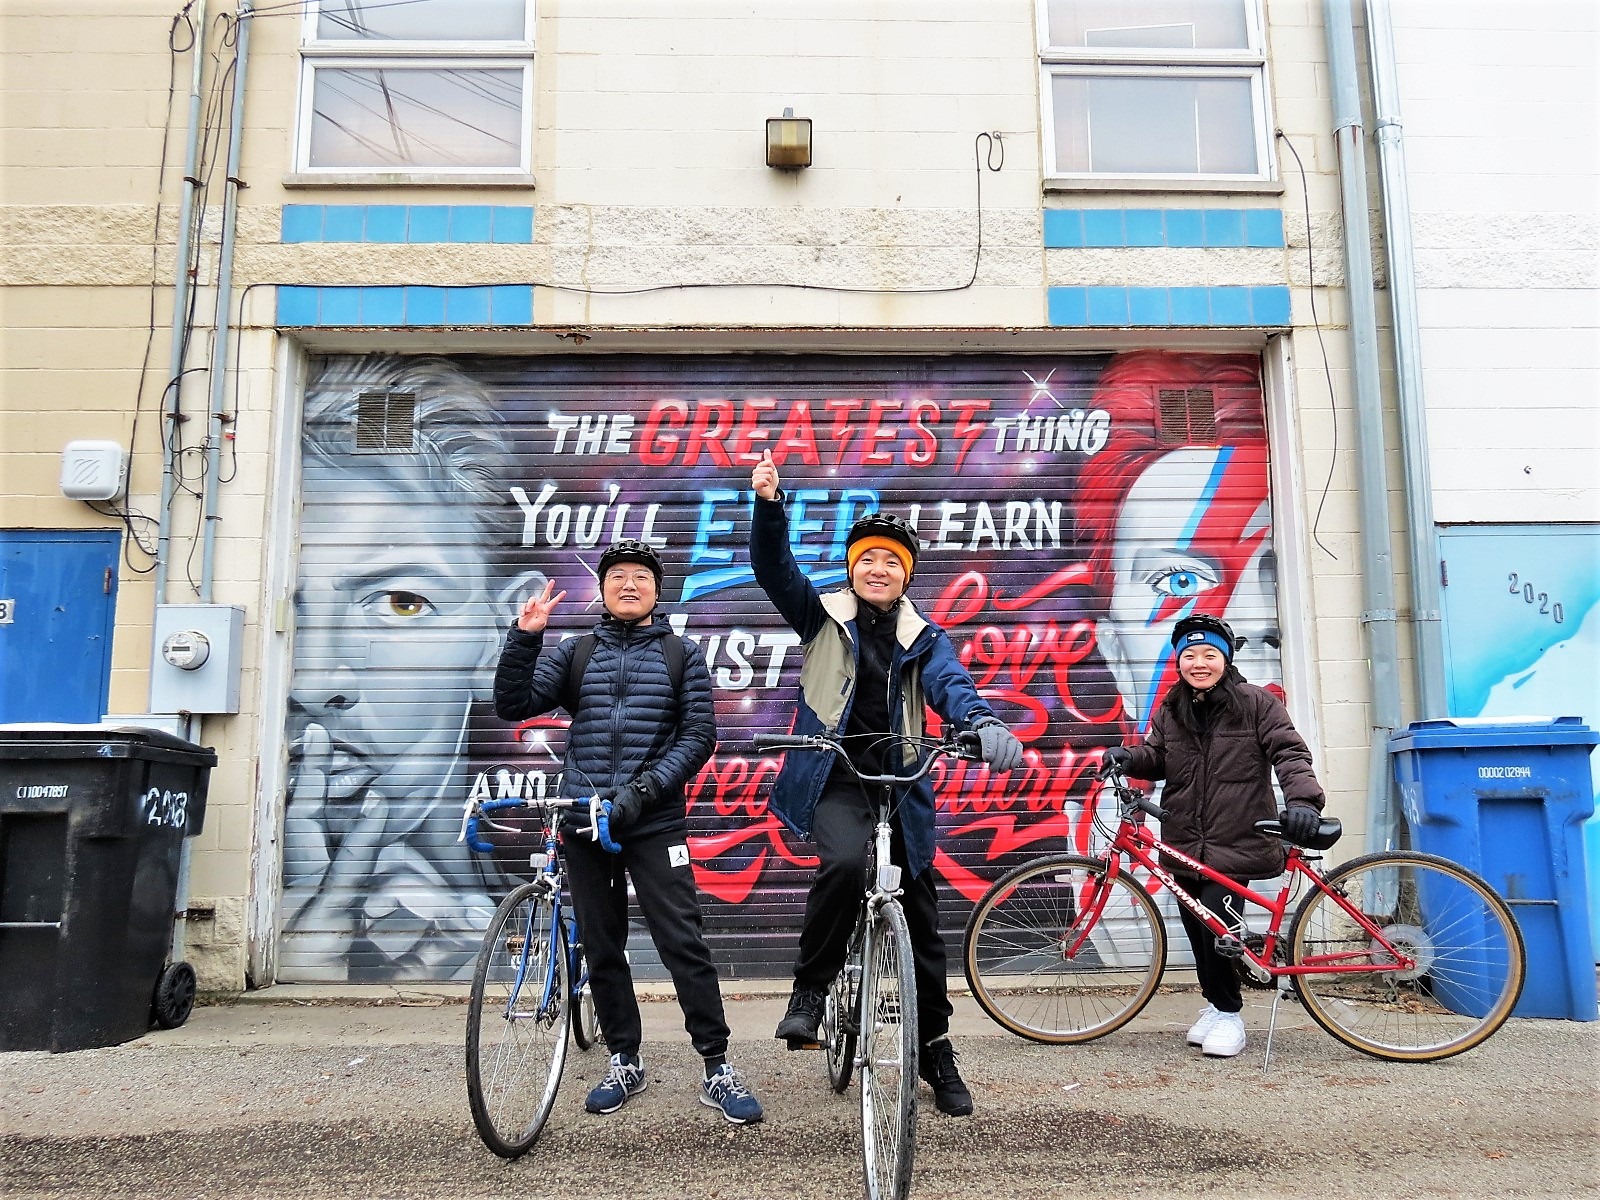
[963,854,1166,1045]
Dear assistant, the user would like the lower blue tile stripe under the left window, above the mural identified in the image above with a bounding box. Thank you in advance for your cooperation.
[277,283,533,328]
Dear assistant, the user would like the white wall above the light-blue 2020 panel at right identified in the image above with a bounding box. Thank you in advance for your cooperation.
[1392,0,1600,525]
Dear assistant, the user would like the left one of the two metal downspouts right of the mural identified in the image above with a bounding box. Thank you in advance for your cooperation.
[1323,0,1400,851]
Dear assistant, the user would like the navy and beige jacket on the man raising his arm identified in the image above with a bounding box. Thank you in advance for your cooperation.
[750,498,994,877]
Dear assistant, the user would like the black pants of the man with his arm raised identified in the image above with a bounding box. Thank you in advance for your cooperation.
[795,784,950,1042]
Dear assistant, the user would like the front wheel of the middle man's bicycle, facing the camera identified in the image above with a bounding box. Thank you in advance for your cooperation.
[859,901,917,1200]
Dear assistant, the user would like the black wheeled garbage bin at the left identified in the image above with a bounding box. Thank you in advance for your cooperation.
[0,725,216,1051]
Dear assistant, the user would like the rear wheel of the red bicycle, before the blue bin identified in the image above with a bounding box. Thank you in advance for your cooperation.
[1290,851,1525,1062]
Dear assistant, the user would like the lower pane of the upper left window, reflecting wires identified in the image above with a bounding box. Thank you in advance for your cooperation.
[310,67,522,170]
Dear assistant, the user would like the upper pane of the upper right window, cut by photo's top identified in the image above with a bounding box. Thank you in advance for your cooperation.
[1048,0,1250,50]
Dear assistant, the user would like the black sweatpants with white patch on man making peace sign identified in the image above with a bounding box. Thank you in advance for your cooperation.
[562,830,728,1058]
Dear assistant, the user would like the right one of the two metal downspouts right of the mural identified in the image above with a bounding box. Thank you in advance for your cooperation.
[1366,0,1448,720]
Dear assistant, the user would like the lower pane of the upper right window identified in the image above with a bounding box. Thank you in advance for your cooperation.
[1051,75,1261,174]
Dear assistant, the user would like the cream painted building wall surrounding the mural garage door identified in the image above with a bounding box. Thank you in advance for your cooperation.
[0,0,1371,986]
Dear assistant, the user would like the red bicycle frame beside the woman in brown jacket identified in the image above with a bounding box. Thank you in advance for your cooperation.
[1094,784,1416,979]
